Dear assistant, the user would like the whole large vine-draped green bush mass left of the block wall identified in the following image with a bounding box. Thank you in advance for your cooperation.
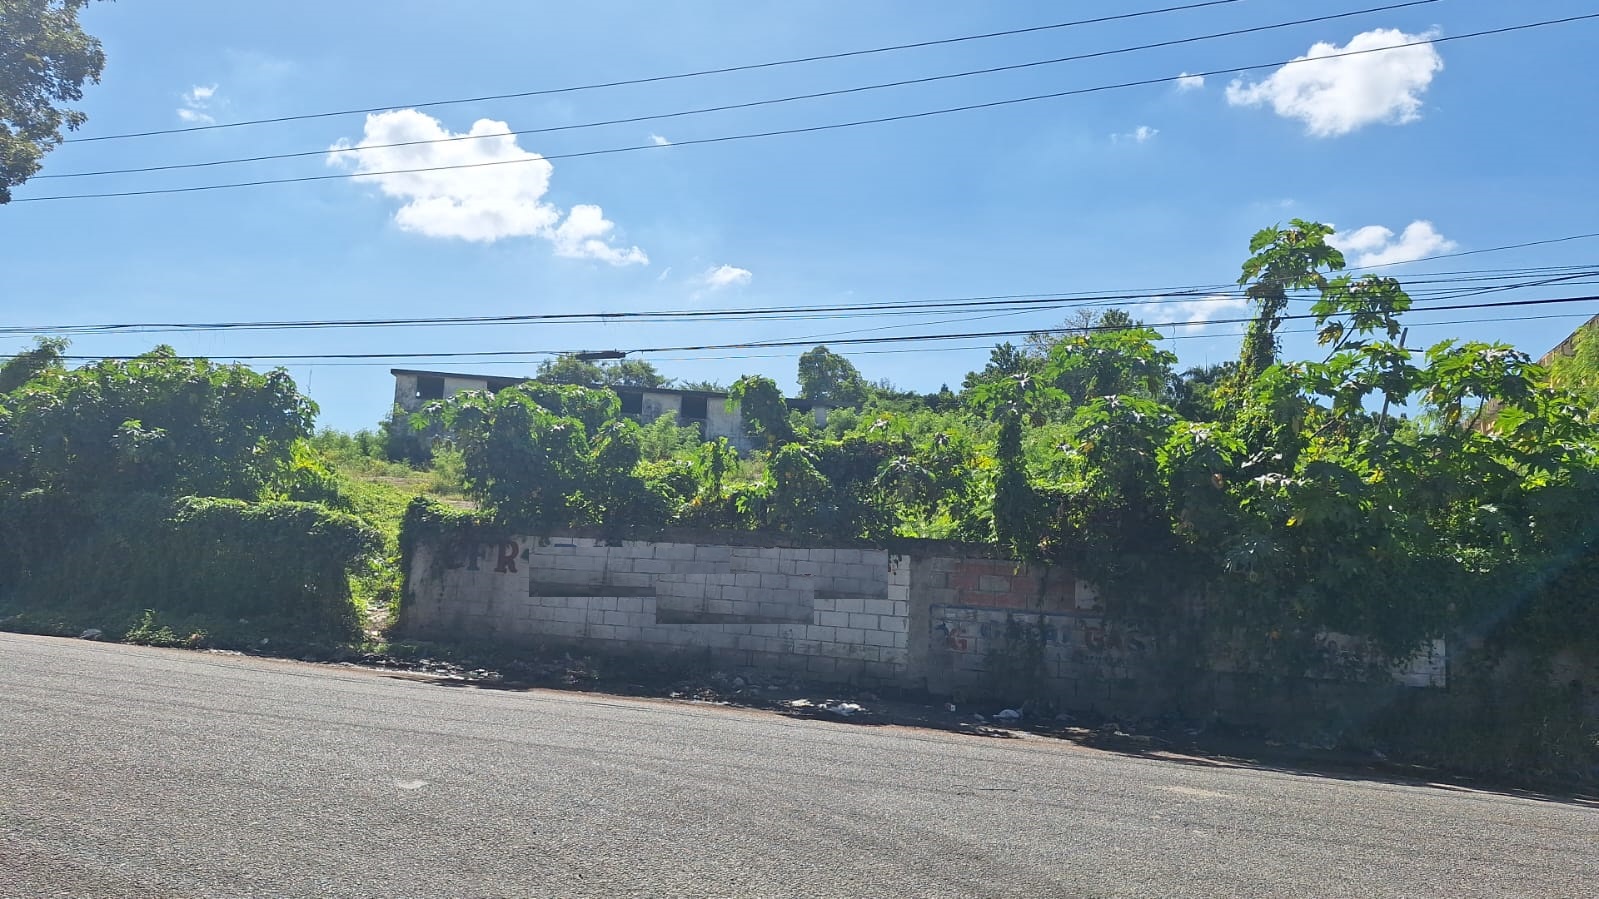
[0,344,379,646]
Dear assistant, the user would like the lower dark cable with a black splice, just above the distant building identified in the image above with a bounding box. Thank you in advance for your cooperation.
[40,294,1599,362]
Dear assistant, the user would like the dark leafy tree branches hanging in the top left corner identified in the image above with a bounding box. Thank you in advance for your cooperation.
[0,0,106,203]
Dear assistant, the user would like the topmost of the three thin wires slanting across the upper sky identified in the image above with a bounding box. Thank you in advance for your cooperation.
[64,0,1241,144]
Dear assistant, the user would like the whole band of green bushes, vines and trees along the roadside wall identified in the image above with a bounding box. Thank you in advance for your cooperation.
[0,221,1599,771]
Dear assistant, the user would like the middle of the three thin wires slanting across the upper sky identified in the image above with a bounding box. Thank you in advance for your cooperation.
[32,0,1438,181]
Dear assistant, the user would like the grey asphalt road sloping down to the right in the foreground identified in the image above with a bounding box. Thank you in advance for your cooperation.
[0,635,1599,899]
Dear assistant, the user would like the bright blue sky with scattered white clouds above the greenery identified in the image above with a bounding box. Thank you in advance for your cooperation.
[0,0,1599,429]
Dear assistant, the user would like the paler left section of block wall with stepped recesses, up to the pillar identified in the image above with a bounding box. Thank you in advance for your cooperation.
[405,537,910,683]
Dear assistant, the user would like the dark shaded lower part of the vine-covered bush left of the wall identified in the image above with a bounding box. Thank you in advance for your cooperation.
[0,491,381,645]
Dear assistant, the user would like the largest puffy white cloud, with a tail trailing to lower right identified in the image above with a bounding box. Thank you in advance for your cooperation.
[328,109,649,266]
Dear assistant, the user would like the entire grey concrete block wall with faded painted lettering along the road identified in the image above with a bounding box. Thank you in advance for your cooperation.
[401,534,1444,715]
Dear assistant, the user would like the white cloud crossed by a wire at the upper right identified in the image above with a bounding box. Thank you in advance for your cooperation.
[1226,29,1444,138]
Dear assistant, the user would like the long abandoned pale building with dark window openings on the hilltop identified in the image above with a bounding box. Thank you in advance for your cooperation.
[390,368,828,453]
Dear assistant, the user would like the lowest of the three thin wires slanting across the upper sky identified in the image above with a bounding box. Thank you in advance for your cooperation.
[11,13,1599,203]
